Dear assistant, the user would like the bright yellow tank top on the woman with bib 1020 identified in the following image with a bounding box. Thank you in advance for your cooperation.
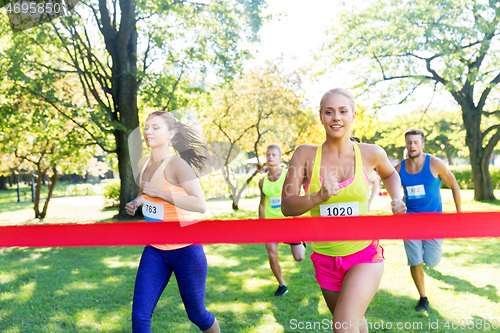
[306,143,372,257]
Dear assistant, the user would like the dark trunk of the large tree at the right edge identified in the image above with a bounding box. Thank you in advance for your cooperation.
[462,105,496,201]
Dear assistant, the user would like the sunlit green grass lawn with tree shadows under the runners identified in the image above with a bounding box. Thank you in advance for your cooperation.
[0,190,500,333]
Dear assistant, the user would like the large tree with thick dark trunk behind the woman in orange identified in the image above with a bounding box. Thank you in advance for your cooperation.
[1,0,265,215]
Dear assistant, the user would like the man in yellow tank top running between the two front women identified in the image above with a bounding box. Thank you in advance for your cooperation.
[259,145,306,296]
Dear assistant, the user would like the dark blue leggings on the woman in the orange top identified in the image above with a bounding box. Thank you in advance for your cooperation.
[132,245,215,333]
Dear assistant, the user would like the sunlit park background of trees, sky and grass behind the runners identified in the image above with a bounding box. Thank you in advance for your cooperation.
[0,0,500,332]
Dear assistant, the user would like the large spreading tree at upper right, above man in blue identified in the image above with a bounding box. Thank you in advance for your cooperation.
[326,0,500,200]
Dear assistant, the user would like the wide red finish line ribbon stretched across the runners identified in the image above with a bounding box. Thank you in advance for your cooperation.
[0,212,500,247]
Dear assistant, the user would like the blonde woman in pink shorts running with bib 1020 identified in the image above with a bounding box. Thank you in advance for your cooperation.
[281,88,406,333]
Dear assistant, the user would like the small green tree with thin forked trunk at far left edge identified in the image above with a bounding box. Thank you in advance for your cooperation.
[0,82,96,219]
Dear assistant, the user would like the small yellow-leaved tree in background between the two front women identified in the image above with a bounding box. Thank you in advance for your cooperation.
[202,62,317,210]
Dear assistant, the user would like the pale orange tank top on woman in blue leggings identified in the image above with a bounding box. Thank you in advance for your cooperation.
[139,155,192,250]
